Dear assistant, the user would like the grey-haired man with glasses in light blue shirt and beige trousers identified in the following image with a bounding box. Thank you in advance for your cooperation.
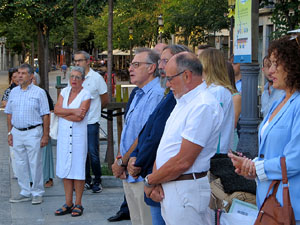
[112,48,164,225]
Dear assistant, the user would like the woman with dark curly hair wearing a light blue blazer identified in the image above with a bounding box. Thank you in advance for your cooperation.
[228,35,300,222]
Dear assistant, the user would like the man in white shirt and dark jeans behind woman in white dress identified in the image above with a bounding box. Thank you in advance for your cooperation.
[74,51,108,193]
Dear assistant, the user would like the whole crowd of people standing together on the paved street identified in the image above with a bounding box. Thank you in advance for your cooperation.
[2,35,300,225]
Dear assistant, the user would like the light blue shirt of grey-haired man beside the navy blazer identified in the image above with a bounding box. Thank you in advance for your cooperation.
[120,77,165,182]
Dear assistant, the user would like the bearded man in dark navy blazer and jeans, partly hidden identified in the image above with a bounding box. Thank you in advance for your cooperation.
[127,45,190,225]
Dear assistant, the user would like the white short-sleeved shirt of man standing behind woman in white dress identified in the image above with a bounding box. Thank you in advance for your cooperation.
[82,68,107,124]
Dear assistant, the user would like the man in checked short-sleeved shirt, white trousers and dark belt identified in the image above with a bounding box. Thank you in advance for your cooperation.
[5,64,50,205]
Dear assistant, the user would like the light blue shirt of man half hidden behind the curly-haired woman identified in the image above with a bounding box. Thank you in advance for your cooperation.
[260,82,284,118]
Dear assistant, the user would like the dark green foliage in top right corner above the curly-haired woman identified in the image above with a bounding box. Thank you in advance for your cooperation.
[261,0,300,39]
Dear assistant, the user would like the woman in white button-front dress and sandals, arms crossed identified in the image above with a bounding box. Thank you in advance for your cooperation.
[54,66,91,217]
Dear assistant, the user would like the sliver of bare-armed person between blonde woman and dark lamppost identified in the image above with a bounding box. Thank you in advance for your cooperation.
[227,62,242,151]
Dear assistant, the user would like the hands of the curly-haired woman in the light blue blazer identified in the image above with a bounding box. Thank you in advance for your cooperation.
[228,151,256,179]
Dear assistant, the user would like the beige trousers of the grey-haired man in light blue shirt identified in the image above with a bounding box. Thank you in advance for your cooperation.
[123,181,152,225]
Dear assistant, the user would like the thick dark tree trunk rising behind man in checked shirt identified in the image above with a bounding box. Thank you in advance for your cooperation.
[37,23,49,91]
